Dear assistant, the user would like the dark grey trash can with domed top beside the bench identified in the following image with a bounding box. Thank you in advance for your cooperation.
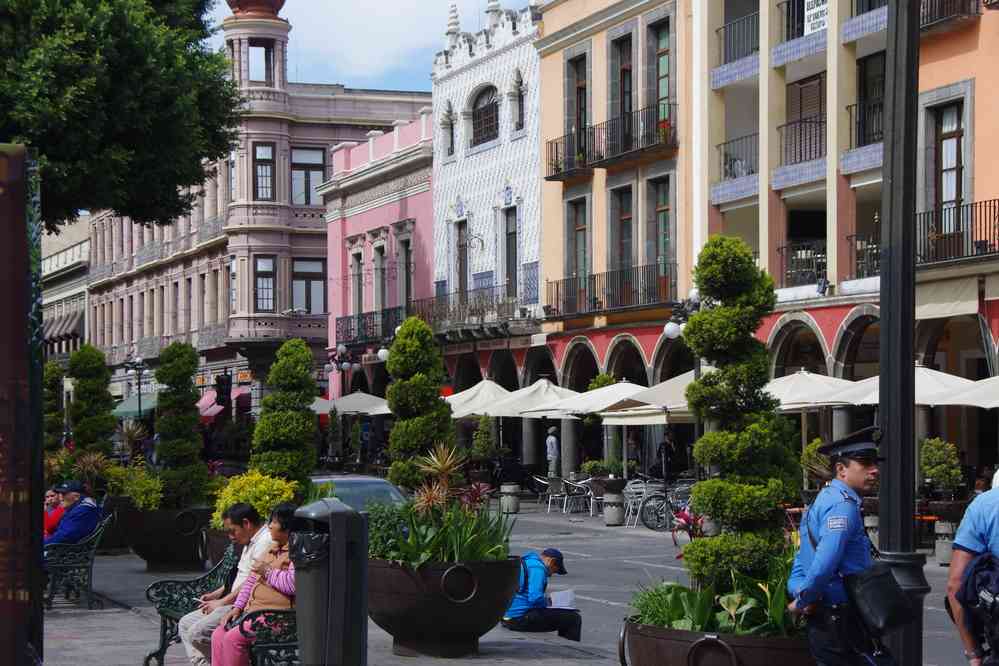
[289,498,368,666]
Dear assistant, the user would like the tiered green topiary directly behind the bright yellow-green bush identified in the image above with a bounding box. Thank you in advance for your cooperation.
[250,338,317,490]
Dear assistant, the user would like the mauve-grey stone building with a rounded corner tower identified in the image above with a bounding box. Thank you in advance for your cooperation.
[90,0,430,410]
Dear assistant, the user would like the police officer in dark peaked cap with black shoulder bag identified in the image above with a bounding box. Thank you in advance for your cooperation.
[787,427,883,666]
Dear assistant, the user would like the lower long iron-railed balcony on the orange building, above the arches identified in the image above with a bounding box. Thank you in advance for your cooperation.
[545,262,676,319]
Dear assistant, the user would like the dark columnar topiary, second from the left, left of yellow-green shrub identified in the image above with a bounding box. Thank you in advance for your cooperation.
[69,345,115,454]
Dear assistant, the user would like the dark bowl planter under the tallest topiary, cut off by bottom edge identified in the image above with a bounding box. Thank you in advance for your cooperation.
[618,618,815,666]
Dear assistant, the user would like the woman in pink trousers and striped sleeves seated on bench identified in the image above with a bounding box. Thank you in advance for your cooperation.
[212,502,295,666]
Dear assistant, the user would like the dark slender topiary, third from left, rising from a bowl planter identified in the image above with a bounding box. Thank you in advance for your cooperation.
[156,342,208,509]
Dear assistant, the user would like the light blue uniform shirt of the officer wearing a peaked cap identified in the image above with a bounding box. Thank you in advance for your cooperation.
[787,479,873,607]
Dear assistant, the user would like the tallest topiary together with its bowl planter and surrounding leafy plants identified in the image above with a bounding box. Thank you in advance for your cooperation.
[625,236,814,666]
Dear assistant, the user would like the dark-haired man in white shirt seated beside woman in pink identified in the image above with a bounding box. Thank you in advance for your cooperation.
[177,502,272,666]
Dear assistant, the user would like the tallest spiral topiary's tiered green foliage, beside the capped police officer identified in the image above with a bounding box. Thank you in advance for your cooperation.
[683,236,801,592]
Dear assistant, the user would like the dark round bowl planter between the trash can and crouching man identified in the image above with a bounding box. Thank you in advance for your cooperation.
[368,557,520,658]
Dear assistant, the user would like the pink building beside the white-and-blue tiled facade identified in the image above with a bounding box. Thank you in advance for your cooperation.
[317,111,434,396]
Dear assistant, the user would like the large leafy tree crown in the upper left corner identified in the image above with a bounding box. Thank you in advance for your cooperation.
[0,0,241,230]
